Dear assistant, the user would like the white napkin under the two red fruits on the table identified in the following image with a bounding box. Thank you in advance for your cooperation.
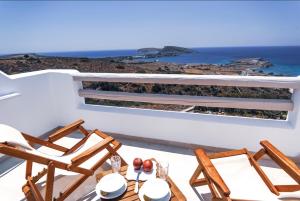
[125,161,156,181]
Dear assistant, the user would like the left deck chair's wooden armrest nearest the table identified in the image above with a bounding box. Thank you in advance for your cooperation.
[71,137,114,166]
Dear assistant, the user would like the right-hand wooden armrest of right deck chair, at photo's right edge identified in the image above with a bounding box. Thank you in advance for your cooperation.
[260,140,300,184]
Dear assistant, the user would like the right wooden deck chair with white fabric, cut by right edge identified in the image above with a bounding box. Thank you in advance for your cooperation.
[190,141,300,201]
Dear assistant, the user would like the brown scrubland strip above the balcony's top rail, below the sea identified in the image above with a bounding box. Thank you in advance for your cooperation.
[0,54,272,76]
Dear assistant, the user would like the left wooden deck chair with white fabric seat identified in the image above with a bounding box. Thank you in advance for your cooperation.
[0,120,126,201]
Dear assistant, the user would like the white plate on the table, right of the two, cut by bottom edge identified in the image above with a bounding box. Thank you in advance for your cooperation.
[139,178,171,201]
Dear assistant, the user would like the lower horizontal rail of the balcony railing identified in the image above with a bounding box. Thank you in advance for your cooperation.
[78,89,293,111]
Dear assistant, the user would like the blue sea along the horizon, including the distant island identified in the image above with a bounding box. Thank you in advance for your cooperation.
[0,46,300,76]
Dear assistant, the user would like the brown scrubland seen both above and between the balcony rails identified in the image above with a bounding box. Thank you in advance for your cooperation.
[0,53,291,119]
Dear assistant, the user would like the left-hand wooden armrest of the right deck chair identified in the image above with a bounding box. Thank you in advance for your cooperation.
[195,149,230,196]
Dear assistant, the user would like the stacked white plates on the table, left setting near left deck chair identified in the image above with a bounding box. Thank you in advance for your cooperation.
[96,173,127,199]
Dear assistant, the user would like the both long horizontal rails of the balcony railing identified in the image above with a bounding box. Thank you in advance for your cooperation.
[73,73,300,111]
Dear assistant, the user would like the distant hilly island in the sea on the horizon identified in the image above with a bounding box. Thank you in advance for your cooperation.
[137,46,195,58]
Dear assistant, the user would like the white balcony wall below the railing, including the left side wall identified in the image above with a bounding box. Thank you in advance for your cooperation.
[0,70,300,157]
